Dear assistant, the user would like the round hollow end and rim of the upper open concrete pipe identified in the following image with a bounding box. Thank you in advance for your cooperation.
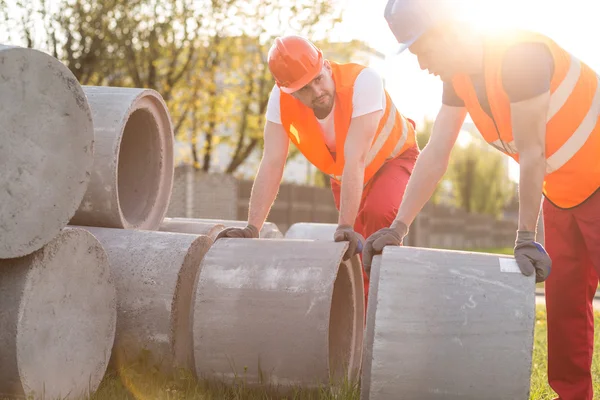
[115,89,174,230]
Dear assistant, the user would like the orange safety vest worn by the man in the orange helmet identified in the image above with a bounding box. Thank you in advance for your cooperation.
[280,62,416,186]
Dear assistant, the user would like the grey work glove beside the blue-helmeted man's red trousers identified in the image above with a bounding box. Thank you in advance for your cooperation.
[515,231,552,282]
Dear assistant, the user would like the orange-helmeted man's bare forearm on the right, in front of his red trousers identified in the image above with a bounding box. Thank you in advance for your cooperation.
[338,162,365,226]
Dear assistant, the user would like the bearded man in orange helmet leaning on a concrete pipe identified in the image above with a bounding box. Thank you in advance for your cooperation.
[217,36,419,306]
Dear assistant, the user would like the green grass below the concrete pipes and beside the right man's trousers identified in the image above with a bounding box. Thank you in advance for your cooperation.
[3,305,600,400]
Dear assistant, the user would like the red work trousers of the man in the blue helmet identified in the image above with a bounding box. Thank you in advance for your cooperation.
[543,191,600,400]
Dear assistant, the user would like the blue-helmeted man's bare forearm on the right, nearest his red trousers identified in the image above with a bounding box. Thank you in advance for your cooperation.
[519,155,546,232]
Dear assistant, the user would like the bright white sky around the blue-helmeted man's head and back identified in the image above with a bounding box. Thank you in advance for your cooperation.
[331,0,600,180]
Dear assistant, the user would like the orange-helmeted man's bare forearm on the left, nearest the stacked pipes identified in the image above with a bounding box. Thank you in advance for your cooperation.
[248,161,283,231]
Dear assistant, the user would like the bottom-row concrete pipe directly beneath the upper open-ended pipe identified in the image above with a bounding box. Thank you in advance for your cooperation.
[78,227,213,373]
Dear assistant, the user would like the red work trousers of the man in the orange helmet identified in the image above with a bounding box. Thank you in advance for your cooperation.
[331,145,419,310]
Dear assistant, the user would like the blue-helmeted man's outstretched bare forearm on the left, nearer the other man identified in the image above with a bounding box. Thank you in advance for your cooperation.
[395,147,448,227]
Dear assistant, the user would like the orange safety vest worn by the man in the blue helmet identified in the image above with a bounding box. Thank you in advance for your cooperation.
[452,30,600,208]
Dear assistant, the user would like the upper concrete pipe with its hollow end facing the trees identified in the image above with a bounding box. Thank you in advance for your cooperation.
[70,86,174,230]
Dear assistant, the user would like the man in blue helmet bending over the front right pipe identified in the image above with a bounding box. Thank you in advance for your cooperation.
[363,0,600,400]
